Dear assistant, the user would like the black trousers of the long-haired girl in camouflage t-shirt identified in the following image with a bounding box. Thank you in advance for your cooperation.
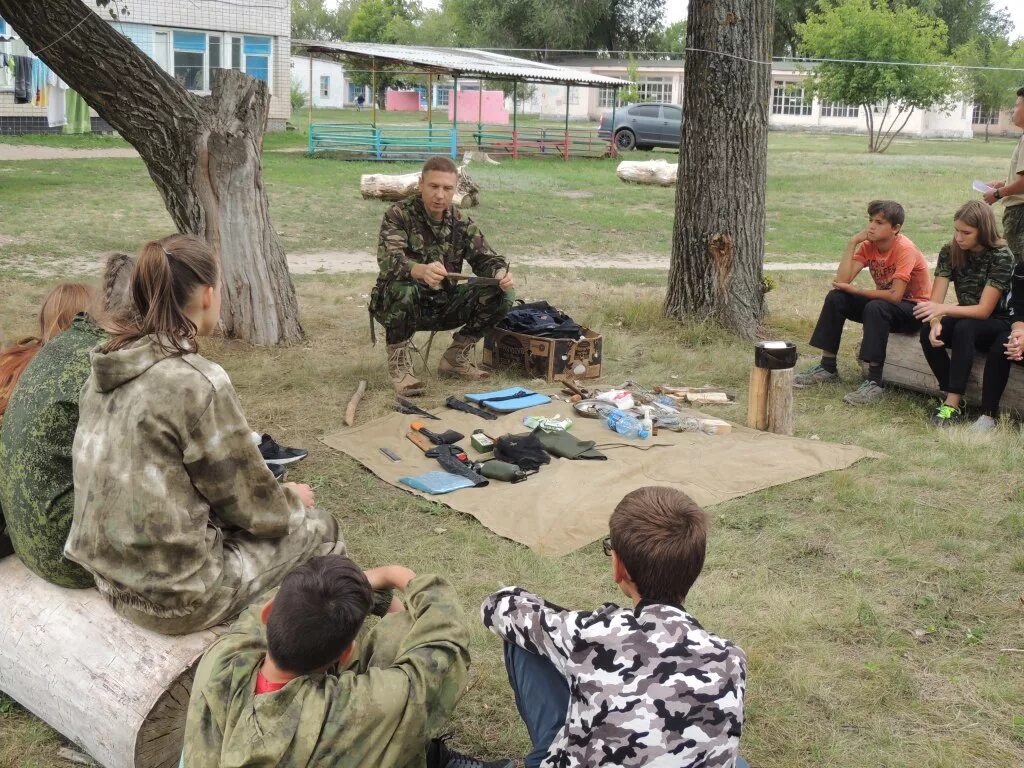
[921,317,1010,406]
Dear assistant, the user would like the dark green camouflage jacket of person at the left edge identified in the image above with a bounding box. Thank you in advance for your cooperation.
[0,313,106,587]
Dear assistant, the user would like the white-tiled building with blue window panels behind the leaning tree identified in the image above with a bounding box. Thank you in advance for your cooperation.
[0,0,292,134]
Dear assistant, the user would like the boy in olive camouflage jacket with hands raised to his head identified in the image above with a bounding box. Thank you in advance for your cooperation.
[182,556,513,768]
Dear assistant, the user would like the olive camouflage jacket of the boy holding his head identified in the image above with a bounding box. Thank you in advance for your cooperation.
[183,574,469,768]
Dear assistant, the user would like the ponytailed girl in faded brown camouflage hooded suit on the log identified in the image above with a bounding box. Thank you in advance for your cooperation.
[65,234,344,634]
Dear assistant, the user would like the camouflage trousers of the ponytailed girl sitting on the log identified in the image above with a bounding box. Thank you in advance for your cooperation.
[111,508,345,635]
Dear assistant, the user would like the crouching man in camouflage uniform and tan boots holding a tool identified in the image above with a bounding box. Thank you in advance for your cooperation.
[370,157,514,395]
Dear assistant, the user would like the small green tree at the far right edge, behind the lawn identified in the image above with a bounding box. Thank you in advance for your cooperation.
[953,36,1024,141]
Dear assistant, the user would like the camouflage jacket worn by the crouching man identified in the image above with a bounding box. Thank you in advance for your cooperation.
[377,195,508,284]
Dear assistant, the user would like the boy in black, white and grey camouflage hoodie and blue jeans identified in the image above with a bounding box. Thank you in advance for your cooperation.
[481,486,746,768]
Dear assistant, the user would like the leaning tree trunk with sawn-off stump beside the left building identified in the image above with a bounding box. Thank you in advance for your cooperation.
[0,0,302,344]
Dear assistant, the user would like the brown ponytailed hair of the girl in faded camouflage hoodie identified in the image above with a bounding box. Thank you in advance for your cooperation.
[103,234,220,354]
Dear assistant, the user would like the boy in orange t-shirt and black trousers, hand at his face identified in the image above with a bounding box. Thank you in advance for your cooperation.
[796,200,932,406]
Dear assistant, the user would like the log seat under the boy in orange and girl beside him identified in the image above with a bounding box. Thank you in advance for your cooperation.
[882,334,1024,418]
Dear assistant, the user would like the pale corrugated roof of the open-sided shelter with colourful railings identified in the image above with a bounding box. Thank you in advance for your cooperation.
[292,40,628,88]
